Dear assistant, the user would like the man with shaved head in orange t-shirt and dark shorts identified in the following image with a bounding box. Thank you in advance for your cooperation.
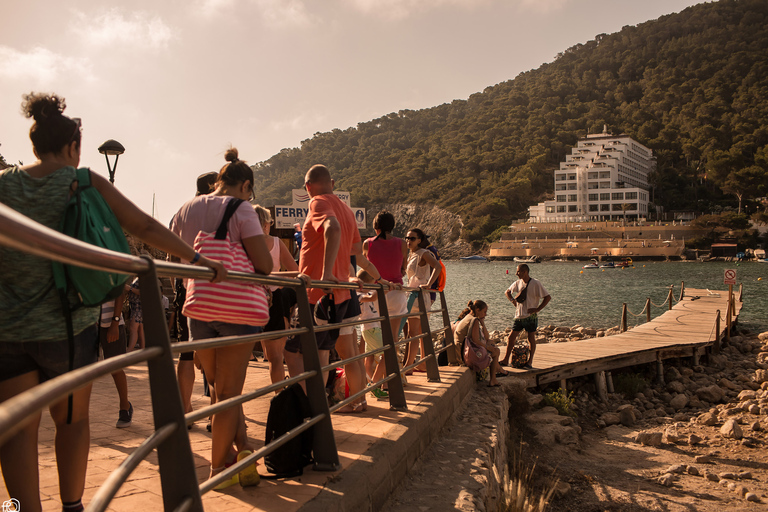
[285,165,381,396]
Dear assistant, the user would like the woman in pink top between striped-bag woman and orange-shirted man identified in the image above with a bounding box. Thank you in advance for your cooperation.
[253,205,299,384]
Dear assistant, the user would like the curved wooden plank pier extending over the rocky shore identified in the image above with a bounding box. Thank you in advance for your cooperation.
[510,288,742,394]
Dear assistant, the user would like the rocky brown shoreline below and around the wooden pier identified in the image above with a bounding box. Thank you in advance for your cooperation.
[390,326,768,512]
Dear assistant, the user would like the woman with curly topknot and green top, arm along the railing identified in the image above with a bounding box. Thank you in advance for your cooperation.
[0,93,227,511]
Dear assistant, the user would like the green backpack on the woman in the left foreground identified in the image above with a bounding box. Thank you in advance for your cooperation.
[53,168,131,311]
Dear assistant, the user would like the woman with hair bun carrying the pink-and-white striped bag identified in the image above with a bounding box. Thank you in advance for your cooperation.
[171,148,272,489]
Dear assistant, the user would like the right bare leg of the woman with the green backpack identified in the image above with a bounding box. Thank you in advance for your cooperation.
[50,384,91,503]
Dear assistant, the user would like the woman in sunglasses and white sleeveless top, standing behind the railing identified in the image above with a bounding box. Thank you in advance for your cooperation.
[403,228,441,375]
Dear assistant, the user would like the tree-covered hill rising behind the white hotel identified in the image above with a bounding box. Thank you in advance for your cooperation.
[254,0,768,240]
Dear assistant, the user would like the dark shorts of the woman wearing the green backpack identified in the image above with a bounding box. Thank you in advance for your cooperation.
[0,324,99,382]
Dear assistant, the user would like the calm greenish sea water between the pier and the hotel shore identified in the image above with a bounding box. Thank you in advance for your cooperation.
[444,261,768,332]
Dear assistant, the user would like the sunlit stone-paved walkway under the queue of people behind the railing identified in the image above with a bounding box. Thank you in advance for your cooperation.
[0,356,475,512]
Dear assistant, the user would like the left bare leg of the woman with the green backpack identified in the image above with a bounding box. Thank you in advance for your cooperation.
[0,370,42,512]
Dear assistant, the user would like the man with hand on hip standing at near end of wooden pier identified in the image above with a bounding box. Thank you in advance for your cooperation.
[499,263,552,370]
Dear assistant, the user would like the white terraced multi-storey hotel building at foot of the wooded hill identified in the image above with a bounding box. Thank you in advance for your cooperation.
[528,129,656,222]
